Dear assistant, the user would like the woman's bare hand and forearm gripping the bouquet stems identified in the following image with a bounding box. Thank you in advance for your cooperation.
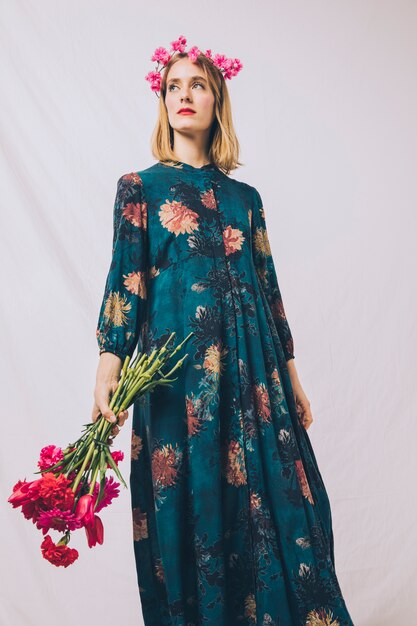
[91,352,129,437]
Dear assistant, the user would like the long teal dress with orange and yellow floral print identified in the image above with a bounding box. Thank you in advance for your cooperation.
[97,162,353,626]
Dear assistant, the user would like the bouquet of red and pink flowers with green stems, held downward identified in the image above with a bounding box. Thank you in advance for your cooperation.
[8,332,194,567]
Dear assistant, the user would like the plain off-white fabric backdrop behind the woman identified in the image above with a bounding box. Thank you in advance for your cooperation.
[0,0,417,626]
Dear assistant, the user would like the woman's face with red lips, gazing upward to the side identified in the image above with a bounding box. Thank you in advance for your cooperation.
[165,57,215,134]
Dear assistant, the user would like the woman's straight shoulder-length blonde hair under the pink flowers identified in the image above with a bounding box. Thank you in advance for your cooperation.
[151,52,243,174]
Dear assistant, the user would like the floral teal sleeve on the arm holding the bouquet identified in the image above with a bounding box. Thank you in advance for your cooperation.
[96,173,148,360]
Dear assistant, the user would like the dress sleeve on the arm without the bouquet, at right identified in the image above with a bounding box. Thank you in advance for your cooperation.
[251,189,295,361]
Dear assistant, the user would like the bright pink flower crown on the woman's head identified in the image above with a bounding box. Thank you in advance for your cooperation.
[145,35,243,97]
